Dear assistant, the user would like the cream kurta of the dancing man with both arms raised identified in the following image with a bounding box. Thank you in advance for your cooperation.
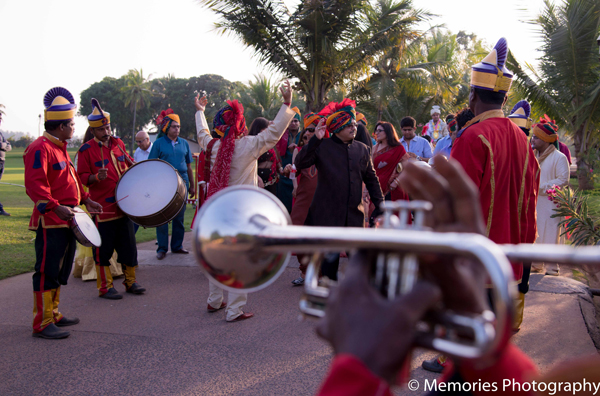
[196,105,296,186]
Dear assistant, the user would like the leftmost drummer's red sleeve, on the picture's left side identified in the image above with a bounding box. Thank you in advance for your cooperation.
[23,145,60,214]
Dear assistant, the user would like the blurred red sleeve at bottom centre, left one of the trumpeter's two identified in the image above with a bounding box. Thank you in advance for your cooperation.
[318,354,392,396]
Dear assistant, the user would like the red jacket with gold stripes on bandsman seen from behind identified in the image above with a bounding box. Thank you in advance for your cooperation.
[451,110,540,282]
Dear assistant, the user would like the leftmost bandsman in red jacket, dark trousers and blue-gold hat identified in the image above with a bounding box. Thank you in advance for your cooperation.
[23,87,102,339]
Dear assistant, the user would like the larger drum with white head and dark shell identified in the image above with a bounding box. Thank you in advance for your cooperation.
[116,159,187,227]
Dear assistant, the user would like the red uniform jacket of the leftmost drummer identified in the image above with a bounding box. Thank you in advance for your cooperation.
[23,132,90,231]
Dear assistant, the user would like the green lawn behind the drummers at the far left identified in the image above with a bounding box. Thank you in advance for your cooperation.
[0,149,194,279]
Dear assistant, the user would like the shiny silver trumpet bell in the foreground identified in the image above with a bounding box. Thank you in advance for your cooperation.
[192,186,291,293]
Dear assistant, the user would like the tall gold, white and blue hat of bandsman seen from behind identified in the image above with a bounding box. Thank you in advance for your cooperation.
[471,37,513,93]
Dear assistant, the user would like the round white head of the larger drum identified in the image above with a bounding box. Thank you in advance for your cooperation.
[116,160,178,217]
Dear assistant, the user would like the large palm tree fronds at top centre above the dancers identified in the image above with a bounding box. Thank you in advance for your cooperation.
[200,0,429,111]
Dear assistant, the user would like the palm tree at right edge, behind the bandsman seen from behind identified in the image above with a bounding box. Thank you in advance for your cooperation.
[509,0,600,190]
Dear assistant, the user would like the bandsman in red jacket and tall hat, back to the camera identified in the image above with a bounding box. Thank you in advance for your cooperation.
[451,38,540,330]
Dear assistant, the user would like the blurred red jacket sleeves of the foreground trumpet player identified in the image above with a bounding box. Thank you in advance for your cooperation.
[318,344,537,396]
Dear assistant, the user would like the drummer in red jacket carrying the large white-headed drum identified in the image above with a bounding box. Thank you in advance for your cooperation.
[77,99,146,300]
